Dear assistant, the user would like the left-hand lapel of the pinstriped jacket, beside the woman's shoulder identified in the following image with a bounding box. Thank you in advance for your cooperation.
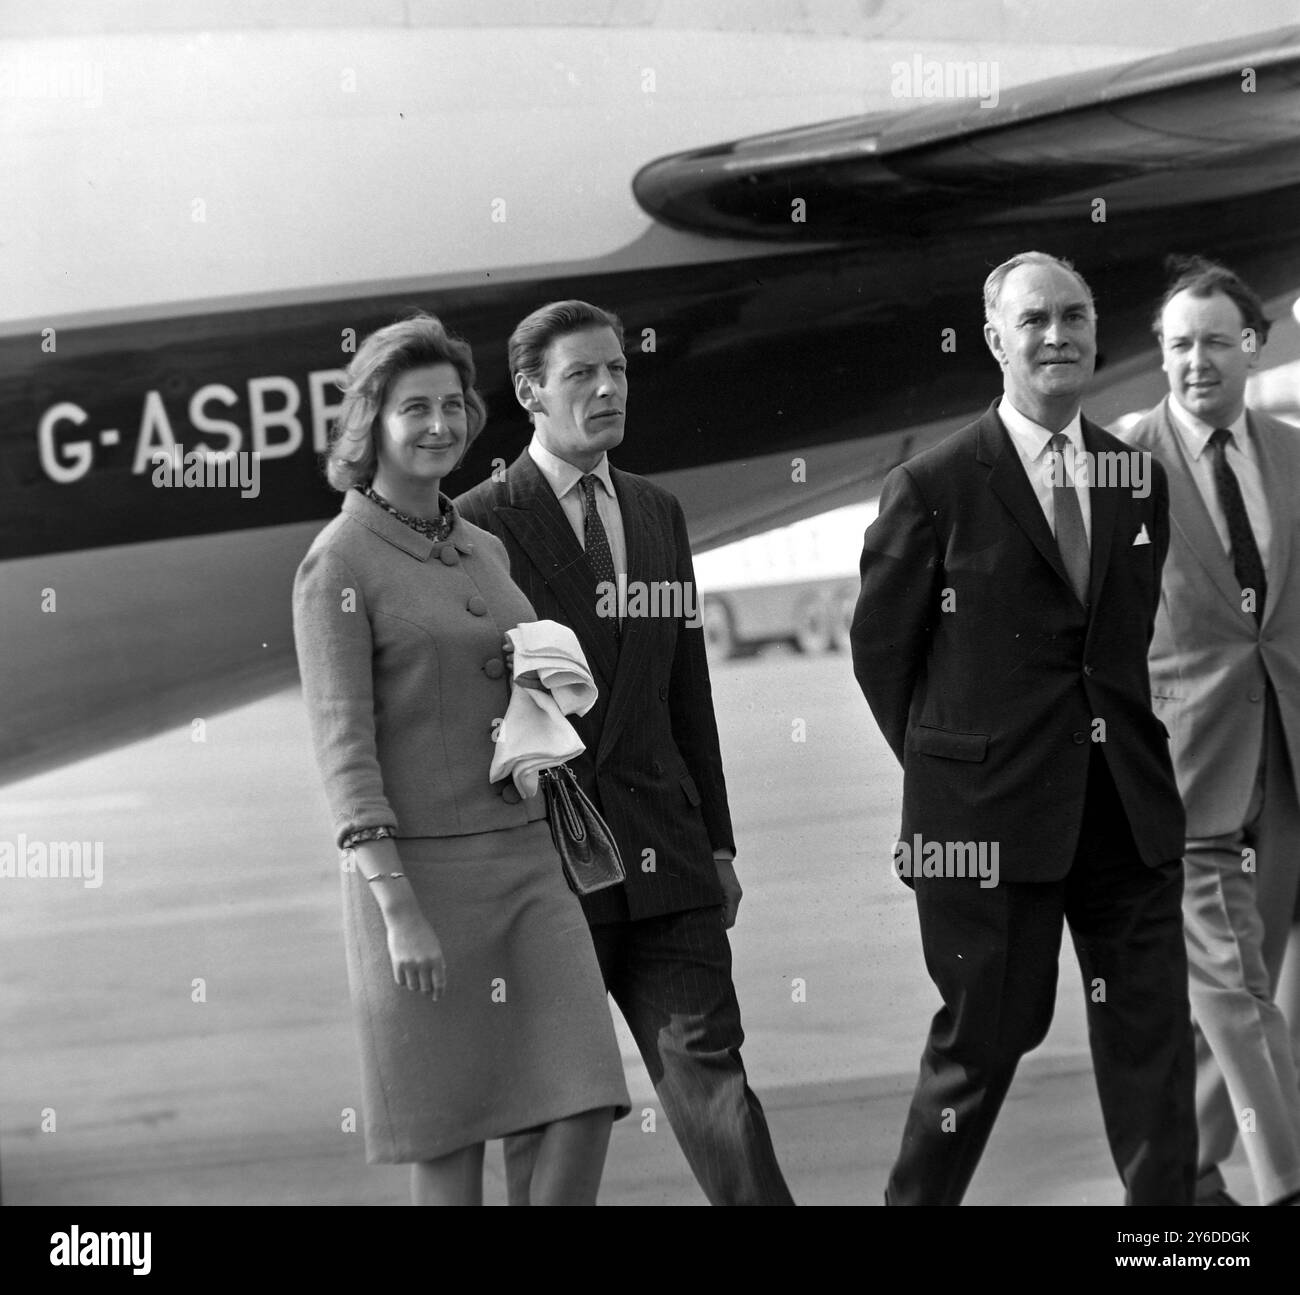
[495,450,619,690]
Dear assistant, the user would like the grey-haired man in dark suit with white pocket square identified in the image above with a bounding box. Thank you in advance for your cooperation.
[852,252,1196,1204]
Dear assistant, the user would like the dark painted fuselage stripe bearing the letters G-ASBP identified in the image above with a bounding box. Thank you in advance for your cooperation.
[0,186,1300,558]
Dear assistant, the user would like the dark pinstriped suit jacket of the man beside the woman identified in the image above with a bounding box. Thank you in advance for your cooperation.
[456,450,735,922]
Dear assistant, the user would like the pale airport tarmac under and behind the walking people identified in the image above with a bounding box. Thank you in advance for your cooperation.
[0,651,1253,1205]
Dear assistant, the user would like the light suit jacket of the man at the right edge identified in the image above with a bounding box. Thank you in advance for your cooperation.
[1125,397,1300,837]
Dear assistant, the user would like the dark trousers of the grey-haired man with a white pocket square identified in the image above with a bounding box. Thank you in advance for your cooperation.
[885,748,1196,1205]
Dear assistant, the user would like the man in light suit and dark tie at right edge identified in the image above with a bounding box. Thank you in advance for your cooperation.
[1125,257,1300,1205]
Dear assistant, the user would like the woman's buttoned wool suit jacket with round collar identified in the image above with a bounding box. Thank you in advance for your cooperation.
[294,490,546,844]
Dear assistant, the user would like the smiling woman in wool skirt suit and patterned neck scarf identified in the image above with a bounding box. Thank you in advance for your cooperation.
[294,315,628,1204]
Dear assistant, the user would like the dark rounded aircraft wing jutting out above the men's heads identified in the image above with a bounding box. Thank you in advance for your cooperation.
[633,26,1300,243]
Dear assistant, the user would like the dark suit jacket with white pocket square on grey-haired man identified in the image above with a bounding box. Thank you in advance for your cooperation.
[852,404,1183,882]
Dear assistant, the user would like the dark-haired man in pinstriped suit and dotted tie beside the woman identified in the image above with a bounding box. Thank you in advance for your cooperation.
[456,302,792,1204]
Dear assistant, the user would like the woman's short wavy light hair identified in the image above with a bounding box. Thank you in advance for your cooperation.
[325,311,488,490]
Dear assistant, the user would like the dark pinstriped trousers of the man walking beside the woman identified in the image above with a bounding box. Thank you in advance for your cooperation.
[506,908,794,1205]
